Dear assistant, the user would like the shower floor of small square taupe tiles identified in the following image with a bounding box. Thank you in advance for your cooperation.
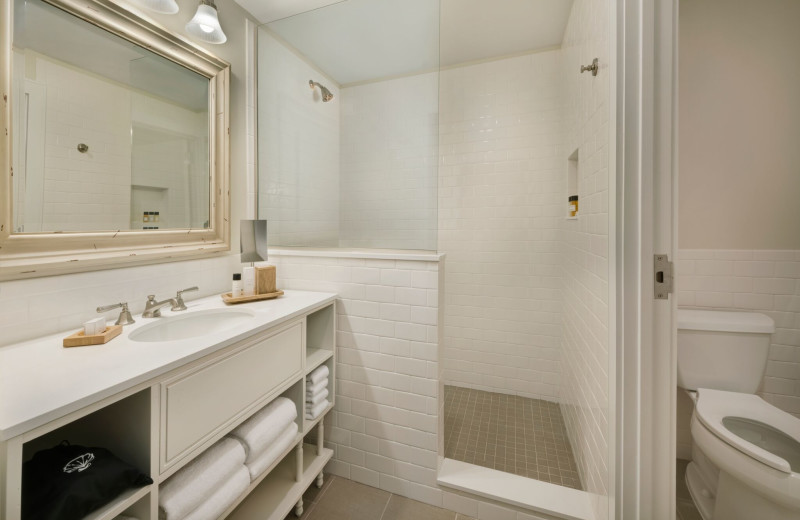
[444,386,583,489]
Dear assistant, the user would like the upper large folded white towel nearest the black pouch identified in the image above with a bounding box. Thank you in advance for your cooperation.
[158,438,245,520]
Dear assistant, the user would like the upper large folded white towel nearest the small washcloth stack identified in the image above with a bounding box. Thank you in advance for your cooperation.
[230,397,297,464]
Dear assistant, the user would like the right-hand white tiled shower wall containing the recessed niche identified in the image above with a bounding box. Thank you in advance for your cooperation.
[561,0,615,520]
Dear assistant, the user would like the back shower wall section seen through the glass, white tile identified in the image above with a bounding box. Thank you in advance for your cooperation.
[339,72,439,250]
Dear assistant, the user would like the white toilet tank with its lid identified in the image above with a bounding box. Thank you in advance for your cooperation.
[678,309,775,394]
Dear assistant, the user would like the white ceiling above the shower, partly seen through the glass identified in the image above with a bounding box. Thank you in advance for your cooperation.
[236,0,572,85]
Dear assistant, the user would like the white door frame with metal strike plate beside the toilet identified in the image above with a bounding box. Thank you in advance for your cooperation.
[615,0,678,520]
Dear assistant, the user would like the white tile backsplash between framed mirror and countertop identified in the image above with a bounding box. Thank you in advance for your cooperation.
[0,255,241,347]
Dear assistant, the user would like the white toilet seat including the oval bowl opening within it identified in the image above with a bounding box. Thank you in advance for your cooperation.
[696,388,800,473]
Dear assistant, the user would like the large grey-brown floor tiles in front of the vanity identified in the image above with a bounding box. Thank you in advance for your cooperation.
[286,476,474,520]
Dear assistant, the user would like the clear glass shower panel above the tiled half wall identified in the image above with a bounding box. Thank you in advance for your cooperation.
[258,0,439,250]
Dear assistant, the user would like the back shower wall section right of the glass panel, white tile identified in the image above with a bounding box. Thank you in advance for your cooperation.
[439,50,566,400]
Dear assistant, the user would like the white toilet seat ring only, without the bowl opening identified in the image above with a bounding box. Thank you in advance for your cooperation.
[695,388,800,474]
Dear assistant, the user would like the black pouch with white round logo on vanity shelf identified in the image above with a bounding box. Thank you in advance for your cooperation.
[22,441,153,520]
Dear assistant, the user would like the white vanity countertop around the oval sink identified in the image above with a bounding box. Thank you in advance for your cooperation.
[0,291,336,441]
